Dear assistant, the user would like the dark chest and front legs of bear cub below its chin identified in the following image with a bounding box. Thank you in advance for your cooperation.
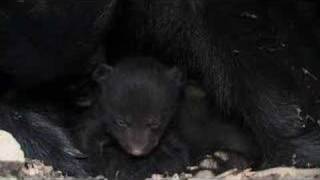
[83,129,190,180]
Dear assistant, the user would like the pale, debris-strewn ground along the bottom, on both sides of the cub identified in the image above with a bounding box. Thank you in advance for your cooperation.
[0,160,320,180]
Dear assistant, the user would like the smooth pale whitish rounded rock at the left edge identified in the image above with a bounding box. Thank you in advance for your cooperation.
[0,130,25,163]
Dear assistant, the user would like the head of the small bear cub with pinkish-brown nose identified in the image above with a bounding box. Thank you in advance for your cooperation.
[94,58,181,156]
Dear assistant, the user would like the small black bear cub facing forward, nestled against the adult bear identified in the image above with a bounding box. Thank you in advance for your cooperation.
[74,58,258,179]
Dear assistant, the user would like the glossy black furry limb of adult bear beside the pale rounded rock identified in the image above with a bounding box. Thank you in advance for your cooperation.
[0,103,87,177]
